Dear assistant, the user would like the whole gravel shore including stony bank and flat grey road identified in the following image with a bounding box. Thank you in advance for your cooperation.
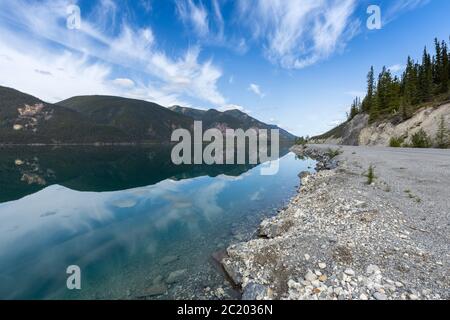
[222,145,450,300]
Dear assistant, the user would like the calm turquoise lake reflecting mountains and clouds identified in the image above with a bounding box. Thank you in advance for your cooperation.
[0,146,315,299]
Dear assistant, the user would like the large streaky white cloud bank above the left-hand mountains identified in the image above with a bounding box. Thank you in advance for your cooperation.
[0,0,226,105]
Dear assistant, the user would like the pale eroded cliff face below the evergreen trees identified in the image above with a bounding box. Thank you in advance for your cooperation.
[312,103,450,147]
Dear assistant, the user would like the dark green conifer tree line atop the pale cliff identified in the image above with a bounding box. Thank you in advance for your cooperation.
[348,38,450,123]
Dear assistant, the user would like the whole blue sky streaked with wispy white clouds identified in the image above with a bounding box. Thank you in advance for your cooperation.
[0,0,450,135]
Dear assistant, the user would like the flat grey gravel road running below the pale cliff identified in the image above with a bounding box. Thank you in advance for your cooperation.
[312,145,450,256]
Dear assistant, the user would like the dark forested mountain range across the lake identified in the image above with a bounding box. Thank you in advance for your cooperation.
[0,86,296,144]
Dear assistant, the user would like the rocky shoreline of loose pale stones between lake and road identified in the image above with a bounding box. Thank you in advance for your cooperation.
[222,147,450,300]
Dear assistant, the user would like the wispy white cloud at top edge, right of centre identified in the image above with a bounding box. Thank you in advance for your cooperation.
[239,0,360,69]
